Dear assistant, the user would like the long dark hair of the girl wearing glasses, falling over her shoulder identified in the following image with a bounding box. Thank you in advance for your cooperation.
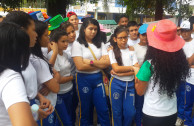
[109,26,128,66]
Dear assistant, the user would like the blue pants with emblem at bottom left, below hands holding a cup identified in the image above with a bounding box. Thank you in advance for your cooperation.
[37,112,56,126]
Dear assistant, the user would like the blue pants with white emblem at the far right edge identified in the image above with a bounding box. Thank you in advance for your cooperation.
[184,83,194,126]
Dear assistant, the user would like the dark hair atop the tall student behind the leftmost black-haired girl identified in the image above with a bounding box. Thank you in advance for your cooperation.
[3,11,33,29]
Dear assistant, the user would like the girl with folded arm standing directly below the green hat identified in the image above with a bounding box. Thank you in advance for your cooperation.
[49,29,75,126]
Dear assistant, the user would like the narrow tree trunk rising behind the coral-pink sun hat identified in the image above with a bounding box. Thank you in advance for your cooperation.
[155,0,164,21]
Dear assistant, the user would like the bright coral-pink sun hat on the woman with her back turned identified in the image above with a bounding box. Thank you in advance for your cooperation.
[147,19,185,52]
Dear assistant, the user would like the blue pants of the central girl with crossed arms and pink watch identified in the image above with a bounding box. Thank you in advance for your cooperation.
[76,72,110,126]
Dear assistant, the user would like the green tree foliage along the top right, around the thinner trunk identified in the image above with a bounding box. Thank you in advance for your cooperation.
[118,0,192,17]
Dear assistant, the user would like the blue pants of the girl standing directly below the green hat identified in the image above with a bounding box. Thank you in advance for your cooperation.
[55,90,75,126]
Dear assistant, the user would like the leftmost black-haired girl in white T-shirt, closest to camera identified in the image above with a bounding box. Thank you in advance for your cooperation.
[0,23,37,126]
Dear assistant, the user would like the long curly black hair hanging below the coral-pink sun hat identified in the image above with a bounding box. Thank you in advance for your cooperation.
[145,46,189,98]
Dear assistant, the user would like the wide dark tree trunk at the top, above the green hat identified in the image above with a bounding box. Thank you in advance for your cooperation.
[46,0,70,17]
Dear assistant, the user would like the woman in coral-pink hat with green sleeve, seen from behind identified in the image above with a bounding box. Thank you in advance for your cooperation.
[134,20,189,126]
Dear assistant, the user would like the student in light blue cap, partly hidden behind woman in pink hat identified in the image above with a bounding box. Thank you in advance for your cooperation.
[133,24,148,126]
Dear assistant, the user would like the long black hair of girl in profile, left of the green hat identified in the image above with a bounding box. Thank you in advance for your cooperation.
[30,21,53,73]
